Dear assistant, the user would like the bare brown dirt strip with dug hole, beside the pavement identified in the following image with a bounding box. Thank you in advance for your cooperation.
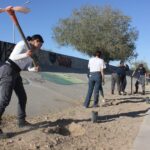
[0,82,150,150]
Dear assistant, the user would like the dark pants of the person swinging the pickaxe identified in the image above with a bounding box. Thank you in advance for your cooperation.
[0,64,27,119]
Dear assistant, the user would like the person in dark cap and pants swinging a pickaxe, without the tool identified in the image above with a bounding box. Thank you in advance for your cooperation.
[0,34,44,138]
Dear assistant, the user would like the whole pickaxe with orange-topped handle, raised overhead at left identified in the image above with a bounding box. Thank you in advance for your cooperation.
[0,6,36,66]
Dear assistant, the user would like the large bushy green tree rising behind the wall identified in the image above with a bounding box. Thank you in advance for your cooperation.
[53,5,138,61]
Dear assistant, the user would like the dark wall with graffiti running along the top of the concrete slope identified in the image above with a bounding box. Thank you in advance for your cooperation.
[0,41,131,74]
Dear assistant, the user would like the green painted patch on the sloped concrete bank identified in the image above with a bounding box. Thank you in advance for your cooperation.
[41,72,85,85]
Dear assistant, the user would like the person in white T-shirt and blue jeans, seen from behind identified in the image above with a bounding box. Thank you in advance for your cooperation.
[83,51,104,108]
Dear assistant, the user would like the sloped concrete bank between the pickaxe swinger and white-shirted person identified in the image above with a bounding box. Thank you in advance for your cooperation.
[4,71,88,116]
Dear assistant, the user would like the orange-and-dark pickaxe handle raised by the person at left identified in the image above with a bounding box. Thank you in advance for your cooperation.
[7,9,36,67]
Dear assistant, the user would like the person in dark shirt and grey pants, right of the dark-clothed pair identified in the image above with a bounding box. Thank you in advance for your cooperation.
[132,64,146,95]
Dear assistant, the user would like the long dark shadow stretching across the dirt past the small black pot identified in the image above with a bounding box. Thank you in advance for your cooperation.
[6,109,149,137]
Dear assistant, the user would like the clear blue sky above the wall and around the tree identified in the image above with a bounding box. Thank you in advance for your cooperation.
[0,0,150,67]
